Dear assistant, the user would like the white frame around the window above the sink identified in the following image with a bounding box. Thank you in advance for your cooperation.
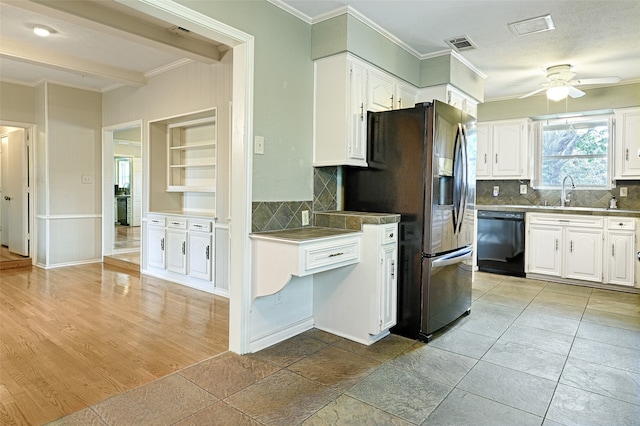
[532,113,615,191]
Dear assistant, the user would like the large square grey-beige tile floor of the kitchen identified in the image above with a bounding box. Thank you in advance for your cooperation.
[47,273,640,425]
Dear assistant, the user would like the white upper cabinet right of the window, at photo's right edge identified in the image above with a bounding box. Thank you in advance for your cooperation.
[614,108,640,179]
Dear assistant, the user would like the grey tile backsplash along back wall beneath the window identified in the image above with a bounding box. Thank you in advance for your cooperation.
[476,180,640,210]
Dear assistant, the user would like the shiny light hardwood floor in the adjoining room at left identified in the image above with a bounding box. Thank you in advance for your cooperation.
[0,264,229,425]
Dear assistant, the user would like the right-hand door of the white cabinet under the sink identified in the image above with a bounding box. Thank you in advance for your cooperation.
[565,228,602,282]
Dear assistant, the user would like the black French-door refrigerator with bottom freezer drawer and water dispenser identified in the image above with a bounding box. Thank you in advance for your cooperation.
[344,101,476,342]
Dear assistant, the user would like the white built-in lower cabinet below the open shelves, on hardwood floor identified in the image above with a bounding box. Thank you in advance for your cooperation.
[142,215,228,296]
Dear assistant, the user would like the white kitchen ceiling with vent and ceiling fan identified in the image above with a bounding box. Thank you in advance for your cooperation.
[282,0,640,100]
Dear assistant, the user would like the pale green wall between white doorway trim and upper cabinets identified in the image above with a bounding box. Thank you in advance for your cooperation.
[177,0,313,201]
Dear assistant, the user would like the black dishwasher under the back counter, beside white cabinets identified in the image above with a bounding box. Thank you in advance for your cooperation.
[477,210,525,277]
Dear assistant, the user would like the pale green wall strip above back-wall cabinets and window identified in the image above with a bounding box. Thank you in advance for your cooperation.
[478,83,640,121]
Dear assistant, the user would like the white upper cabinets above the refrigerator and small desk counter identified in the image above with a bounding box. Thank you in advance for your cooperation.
[313,54,417,167]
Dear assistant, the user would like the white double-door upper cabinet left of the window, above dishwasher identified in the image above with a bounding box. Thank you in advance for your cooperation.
[476,118,529,180]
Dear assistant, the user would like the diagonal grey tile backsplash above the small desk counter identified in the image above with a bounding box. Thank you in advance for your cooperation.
[251,167,338,232]
